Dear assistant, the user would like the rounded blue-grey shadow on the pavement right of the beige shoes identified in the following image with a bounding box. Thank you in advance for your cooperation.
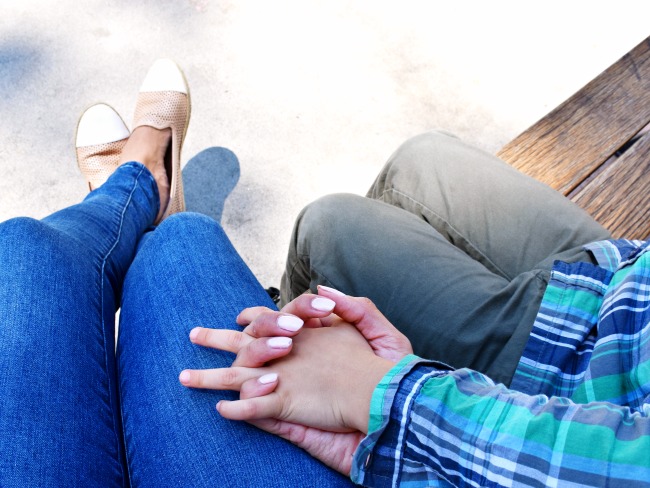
[183,147,240,222]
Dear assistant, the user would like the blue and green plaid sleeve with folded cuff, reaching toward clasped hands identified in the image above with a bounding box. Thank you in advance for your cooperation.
[352,356,650,488]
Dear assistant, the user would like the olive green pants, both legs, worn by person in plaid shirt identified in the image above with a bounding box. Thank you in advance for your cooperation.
[282,132,610,385]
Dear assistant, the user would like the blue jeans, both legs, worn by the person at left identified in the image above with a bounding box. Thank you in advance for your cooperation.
[0,163,351,487]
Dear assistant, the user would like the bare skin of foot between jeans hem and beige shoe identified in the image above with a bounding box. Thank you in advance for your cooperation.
[120,125,172,223]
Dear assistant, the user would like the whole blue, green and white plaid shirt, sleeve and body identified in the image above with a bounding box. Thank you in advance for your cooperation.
[352,240,650,488]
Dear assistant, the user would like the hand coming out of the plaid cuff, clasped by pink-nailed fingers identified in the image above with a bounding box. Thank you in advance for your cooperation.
[181,322,393,432]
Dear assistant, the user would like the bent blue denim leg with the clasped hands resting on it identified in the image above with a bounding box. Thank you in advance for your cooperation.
[117,213,351,487]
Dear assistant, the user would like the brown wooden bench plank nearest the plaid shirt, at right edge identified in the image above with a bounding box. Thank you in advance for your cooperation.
[572,134,650,239]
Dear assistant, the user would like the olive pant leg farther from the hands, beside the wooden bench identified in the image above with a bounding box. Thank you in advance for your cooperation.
[368,132,610,279]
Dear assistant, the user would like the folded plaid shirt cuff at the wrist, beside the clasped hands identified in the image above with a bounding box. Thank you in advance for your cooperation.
[350,354,453,487]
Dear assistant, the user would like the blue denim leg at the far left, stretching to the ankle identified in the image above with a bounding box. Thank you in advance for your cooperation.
[0,163,158,487]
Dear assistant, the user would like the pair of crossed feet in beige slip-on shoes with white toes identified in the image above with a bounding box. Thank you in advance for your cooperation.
[76,59,191,224]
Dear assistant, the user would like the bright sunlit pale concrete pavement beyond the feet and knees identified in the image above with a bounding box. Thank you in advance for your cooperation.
[0,0,650,286]
